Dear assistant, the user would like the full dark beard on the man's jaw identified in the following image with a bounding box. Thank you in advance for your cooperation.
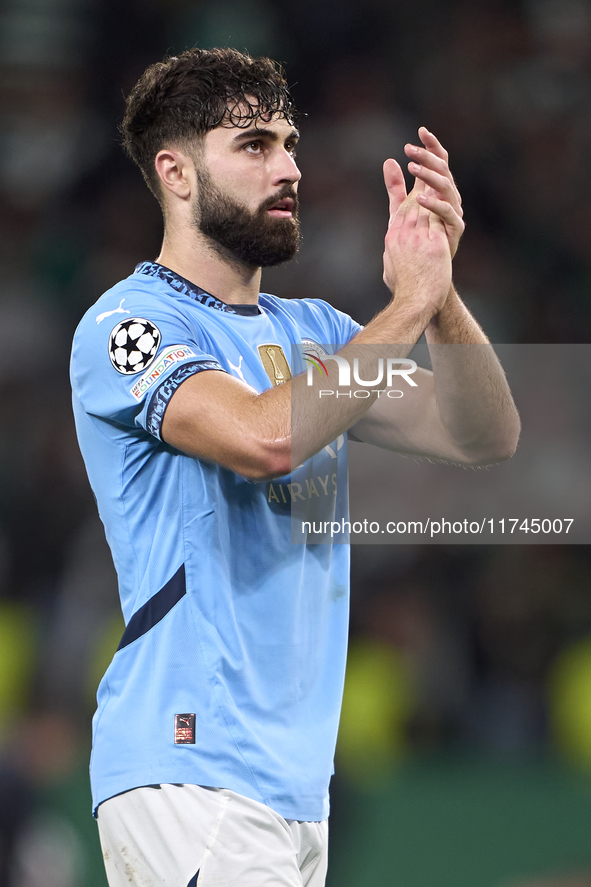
[193,169,300,268]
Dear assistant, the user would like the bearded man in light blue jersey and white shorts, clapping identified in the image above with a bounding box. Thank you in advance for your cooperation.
[72,49,519,887]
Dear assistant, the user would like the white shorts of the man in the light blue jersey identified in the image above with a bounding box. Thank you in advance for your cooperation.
[98,785,328,887]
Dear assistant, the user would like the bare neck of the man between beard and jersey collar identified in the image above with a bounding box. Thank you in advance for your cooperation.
[156,224,261,305]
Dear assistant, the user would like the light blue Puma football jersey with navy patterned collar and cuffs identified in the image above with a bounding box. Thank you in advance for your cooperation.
[71,262,360,821]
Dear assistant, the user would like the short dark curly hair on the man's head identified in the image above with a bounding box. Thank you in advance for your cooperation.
[121,49,296,201]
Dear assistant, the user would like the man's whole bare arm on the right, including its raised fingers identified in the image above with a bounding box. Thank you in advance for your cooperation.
[351,130,520,465]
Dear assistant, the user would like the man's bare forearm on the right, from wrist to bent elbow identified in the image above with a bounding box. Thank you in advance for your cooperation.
[425,287,520,464]
